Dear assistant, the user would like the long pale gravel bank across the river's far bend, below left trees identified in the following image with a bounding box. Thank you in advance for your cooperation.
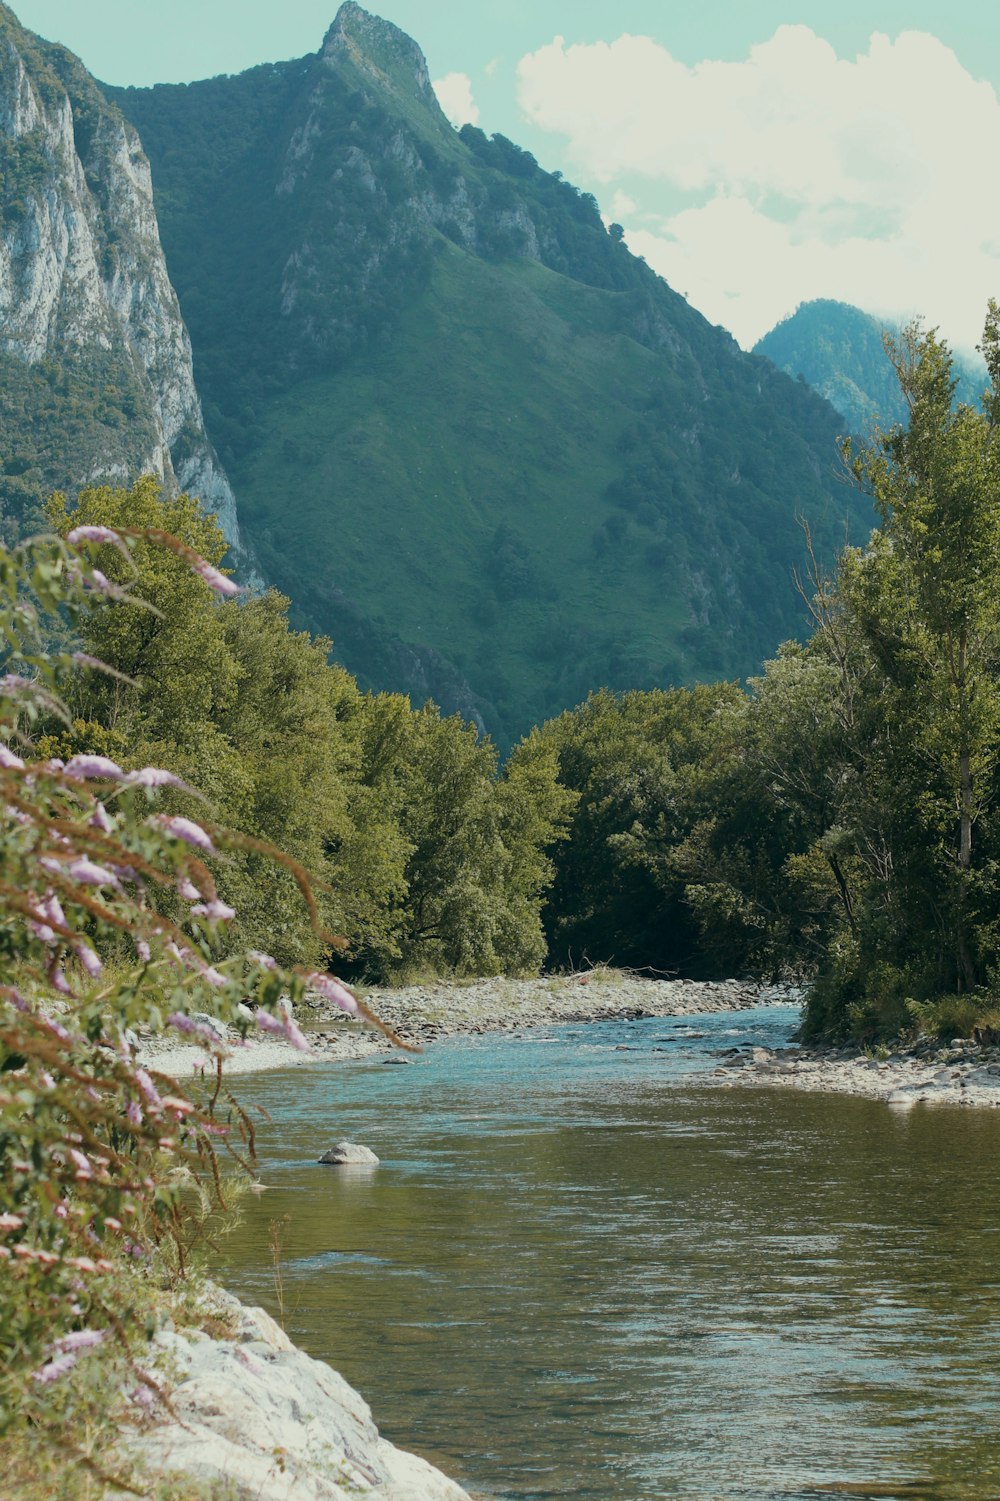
[141,970,774,1079]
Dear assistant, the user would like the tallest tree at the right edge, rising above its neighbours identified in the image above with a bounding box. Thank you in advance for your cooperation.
[839,316,1000,991]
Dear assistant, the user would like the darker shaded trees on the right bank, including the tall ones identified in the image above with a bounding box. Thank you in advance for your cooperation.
[544,306,1000,1036]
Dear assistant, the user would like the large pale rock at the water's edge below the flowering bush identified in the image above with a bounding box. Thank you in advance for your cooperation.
[128,1289,468,1501]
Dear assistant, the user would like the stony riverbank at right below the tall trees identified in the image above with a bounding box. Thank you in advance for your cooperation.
[715,1039,1000,1109]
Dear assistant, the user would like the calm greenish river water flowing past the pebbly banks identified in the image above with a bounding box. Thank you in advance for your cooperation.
[219,1007,1000,1501]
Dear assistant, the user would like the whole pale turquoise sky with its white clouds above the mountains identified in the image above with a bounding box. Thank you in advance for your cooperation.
[14,0,1000,351]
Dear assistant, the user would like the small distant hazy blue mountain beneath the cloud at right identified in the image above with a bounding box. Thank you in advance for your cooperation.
[754,297,986,432]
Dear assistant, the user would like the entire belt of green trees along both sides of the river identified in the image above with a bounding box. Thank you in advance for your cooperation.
[41,316,1000,1036]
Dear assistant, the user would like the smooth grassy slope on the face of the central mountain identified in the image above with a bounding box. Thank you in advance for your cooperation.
[236,242,699,725]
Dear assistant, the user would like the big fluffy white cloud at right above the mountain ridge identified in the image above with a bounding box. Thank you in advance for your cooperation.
[518,26,1000,347]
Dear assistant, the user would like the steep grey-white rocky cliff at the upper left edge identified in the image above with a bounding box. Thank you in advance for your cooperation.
[0,5,239,543]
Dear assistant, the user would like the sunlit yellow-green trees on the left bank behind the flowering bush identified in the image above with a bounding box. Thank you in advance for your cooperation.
[38,480,572,977]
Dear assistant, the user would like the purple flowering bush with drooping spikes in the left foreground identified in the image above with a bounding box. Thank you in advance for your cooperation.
[0,527,373,1472]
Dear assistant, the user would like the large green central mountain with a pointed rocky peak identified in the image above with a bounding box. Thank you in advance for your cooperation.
[108,3,869,741]
